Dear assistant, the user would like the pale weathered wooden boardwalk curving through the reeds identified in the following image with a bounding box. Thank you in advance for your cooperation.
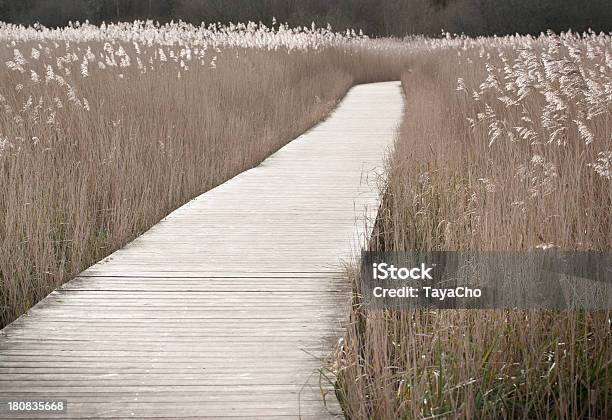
[0,82,403,418]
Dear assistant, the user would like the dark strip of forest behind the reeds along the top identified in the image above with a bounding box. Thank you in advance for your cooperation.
[0,0,612,36]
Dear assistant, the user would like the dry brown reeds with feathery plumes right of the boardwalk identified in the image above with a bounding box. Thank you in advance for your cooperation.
[337,35,612,419]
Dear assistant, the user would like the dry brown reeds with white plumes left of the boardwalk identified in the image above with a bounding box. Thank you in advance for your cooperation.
[0,24,412,326]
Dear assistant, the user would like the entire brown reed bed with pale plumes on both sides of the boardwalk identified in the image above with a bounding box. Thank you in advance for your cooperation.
[0,18,612,419]
